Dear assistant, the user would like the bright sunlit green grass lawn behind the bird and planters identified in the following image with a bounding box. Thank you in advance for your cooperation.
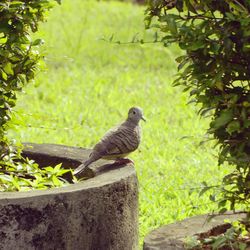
[9,0,232,246]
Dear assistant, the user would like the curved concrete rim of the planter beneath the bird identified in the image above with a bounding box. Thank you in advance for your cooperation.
[0,143,137,200]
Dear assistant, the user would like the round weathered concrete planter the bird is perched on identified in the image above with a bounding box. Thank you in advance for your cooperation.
[0,145,138,250]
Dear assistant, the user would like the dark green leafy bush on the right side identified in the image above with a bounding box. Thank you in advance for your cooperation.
[146,0,250,209]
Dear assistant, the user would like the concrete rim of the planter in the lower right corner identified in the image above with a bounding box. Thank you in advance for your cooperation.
[143,213,246,250]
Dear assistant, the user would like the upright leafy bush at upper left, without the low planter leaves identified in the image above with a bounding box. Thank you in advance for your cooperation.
[0,0,59,146]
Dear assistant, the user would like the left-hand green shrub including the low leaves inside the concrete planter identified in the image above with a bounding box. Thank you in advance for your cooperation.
[0,0,72,191]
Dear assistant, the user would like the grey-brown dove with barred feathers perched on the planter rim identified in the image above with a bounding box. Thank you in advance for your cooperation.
[73,107,146,175]
